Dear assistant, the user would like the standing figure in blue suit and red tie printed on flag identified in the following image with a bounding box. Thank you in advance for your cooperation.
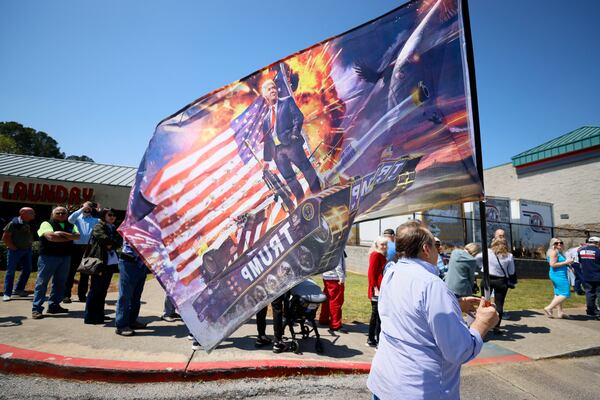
[261,80,321,203]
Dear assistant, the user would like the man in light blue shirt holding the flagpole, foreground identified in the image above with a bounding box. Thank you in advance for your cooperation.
[367,221,498,400]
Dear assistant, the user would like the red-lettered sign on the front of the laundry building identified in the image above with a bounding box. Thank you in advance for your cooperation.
[2,182,94,204]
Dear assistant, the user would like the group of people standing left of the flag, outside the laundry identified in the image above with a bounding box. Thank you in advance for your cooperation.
[2,201,147,336]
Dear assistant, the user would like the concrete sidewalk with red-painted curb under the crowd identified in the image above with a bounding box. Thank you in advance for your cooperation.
[0,279,600,381]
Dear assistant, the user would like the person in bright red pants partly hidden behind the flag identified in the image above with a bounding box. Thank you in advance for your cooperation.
[319,252,346,331]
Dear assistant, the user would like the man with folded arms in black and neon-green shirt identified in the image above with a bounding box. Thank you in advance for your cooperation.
[31,206,79,319]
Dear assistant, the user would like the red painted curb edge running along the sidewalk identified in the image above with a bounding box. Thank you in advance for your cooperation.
[0,344,530,383]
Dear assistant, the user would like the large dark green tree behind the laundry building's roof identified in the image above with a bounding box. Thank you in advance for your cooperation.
[0,122,65,158]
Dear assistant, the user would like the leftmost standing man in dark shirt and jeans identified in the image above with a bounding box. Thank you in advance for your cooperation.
[2,207,35,301]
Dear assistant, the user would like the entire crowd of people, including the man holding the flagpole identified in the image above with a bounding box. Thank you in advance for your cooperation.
[2,202,600,399]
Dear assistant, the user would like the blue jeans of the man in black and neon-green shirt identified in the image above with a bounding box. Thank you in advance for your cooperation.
[32,255,71,312]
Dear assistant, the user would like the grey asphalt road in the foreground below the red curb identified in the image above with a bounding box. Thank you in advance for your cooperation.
[0,356,600,400]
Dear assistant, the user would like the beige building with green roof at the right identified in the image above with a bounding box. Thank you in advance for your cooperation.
[483,126,600,231]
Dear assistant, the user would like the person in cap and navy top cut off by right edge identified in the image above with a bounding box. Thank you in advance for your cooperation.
[577,236,600,319]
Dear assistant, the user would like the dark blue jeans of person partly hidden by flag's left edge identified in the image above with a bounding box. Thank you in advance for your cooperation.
[115,260,147,329]
